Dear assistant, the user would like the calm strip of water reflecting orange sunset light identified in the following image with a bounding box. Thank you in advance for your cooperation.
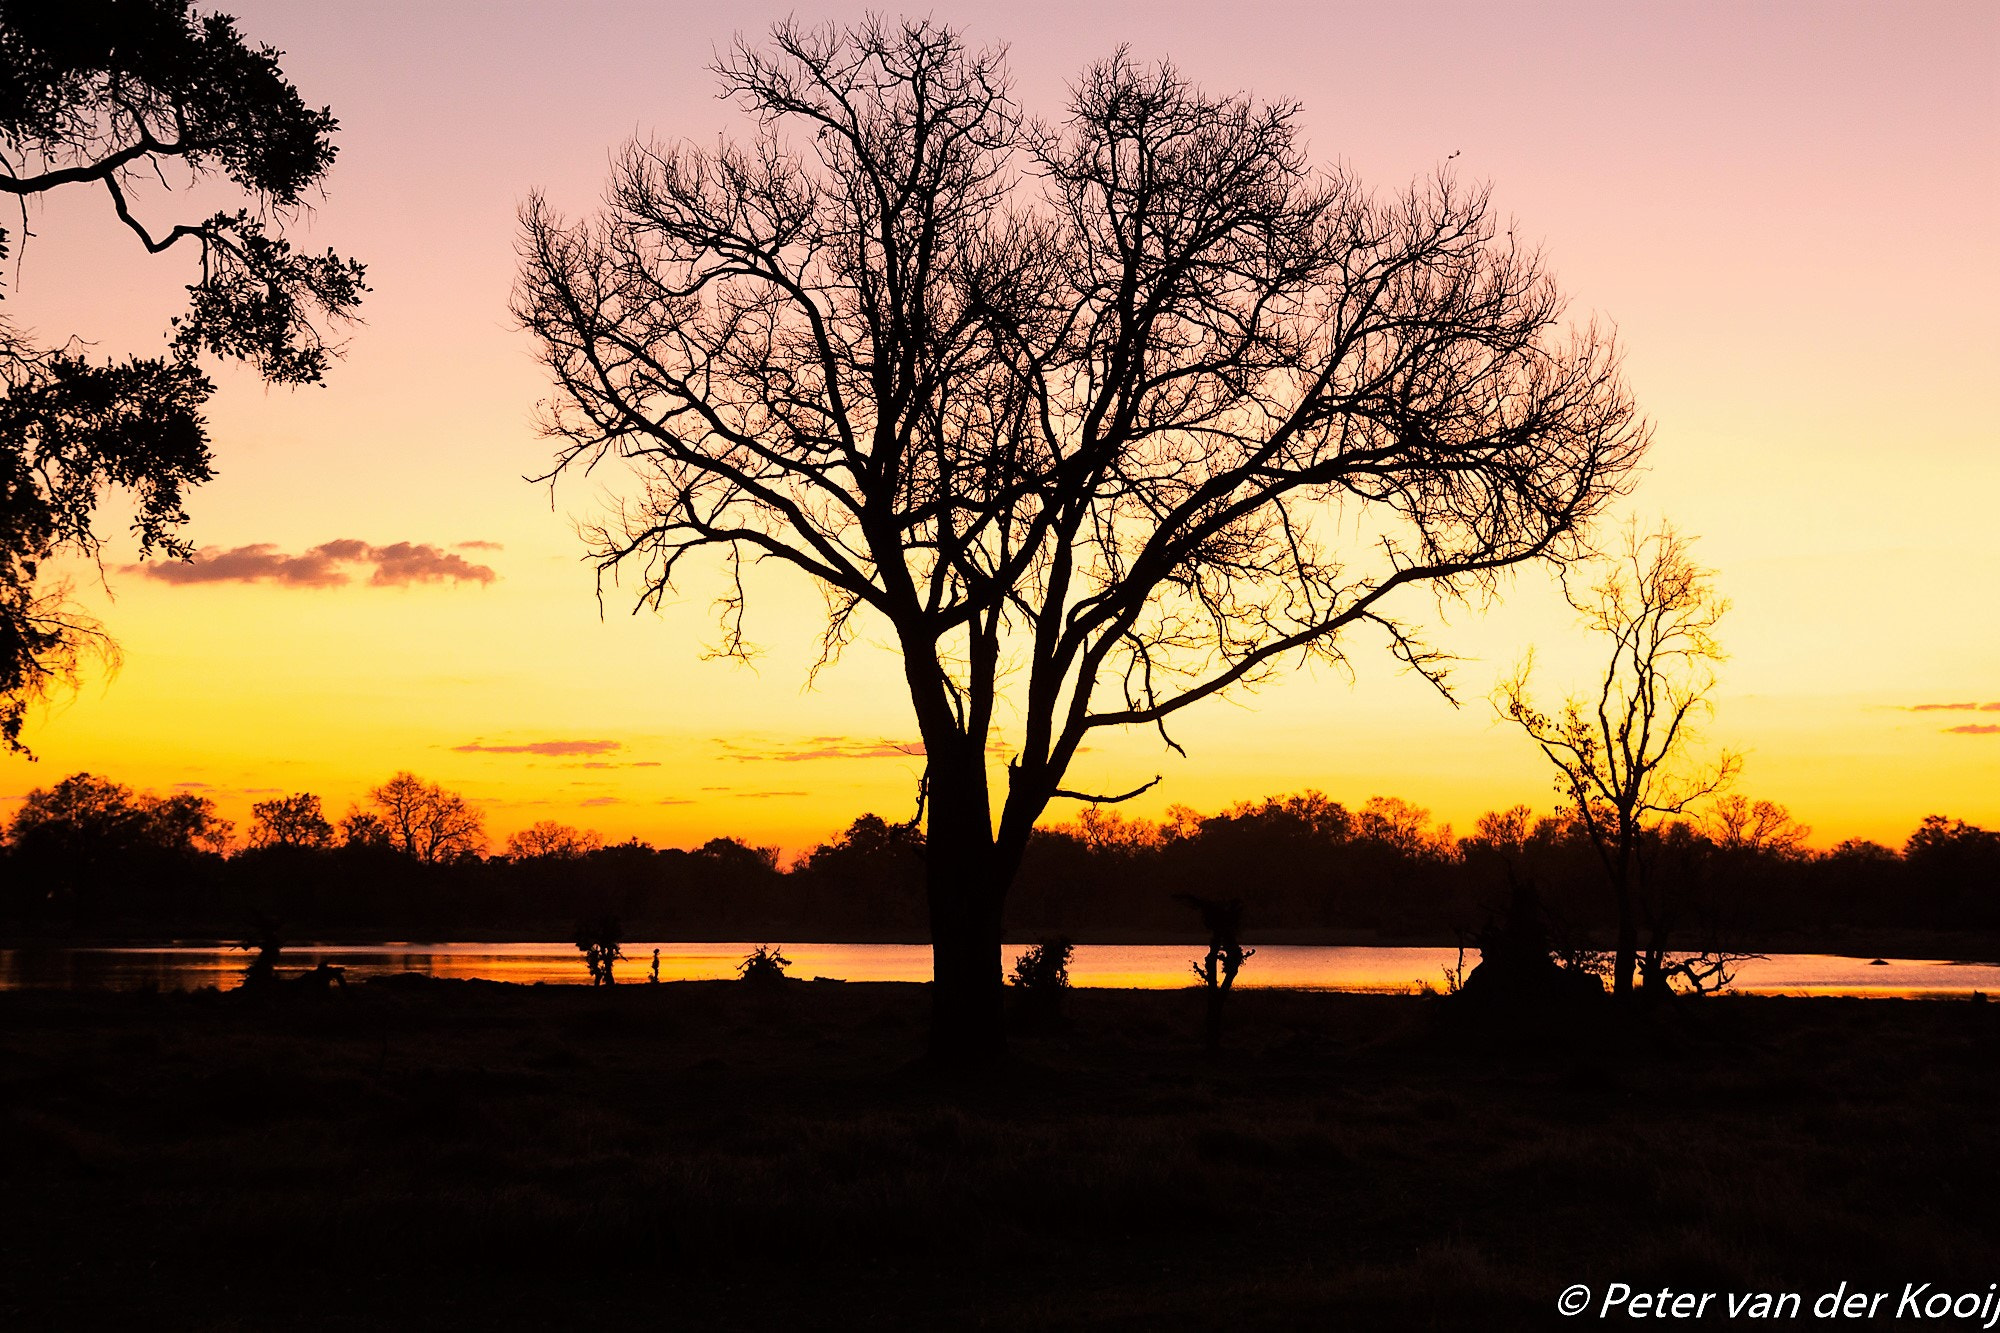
[0,943,2000,997]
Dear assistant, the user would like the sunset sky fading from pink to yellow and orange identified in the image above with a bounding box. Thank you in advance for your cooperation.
[0,0,2000,849]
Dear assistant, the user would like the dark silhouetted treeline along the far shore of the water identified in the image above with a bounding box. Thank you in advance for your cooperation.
[0,775,2000,949]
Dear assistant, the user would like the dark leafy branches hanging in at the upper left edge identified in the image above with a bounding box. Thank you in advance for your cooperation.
[0,0,366,751]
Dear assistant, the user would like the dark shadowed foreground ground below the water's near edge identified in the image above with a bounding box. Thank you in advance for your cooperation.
[0,979,2000,1329]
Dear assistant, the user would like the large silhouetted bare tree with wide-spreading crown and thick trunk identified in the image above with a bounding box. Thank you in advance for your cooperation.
[514,20,1646,1059]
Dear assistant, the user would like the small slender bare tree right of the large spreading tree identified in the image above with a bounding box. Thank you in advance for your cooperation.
[1494,524,1740,995]
